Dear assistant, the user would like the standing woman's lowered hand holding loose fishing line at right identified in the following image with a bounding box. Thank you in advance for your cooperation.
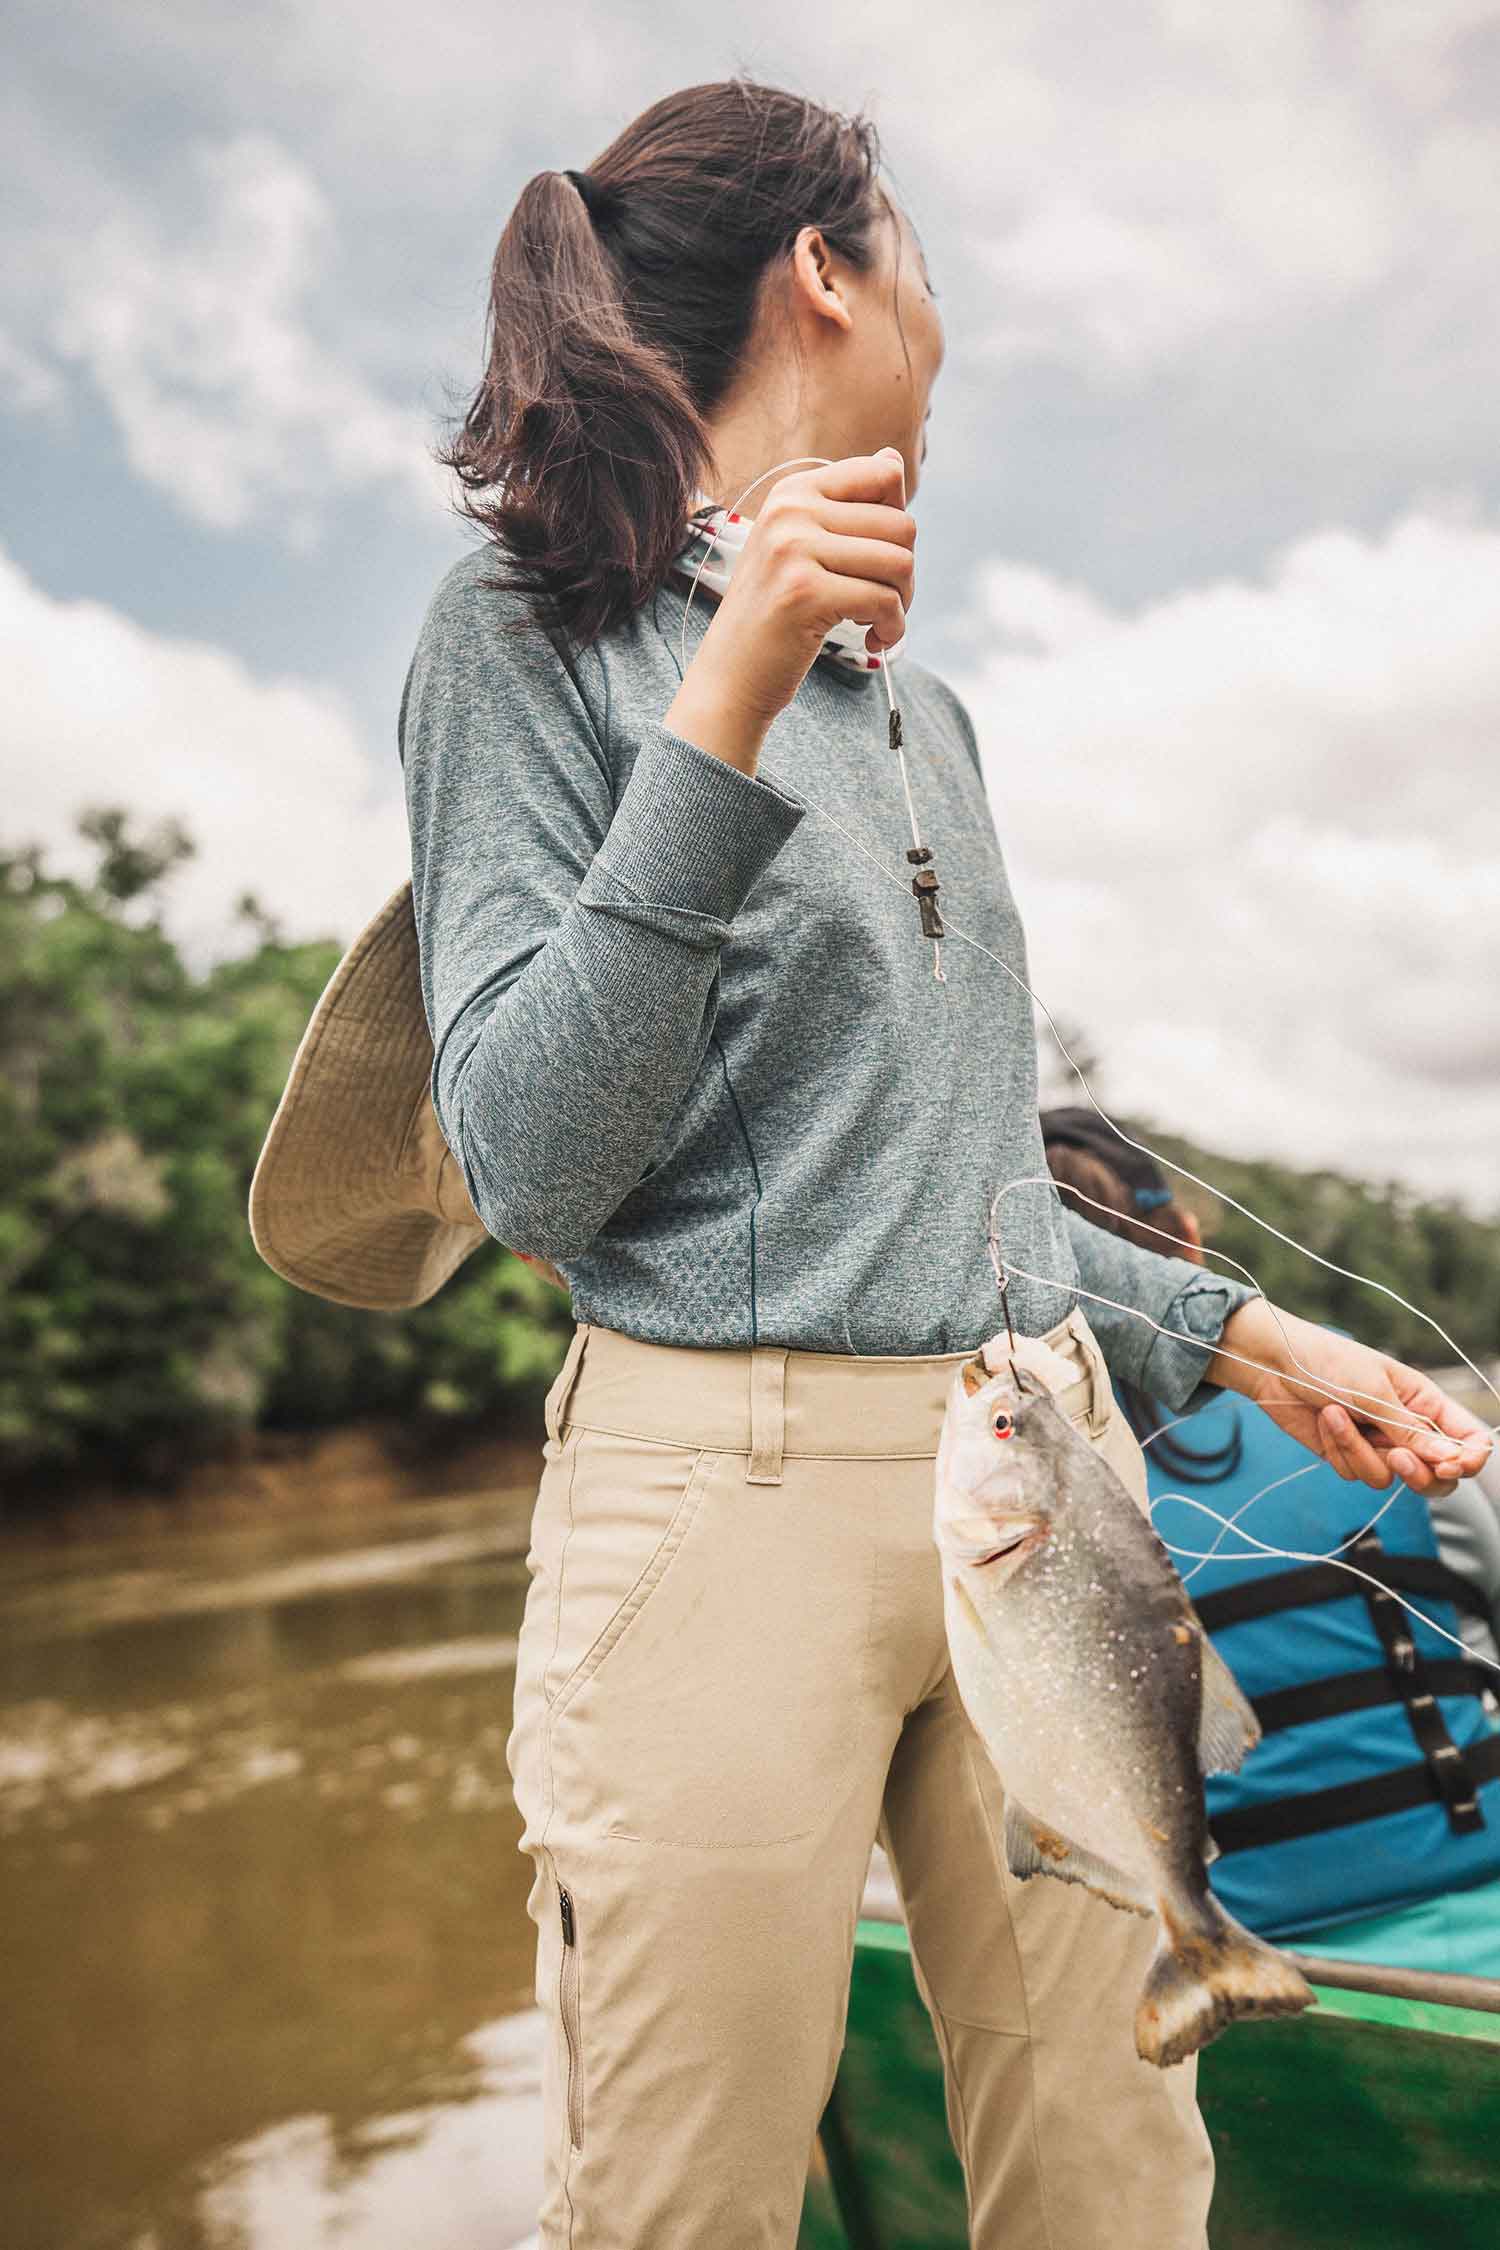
[1203,1296,1493,1496]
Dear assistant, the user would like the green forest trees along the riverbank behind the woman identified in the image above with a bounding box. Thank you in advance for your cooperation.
[0,808,1500,1494]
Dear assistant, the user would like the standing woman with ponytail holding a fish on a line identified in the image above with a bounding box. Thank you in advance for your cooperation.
[400,79,1482,2250]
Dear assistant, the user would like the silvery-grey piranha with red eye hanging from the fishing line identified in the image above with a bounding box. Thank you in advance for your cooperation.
[933,1339,1313,2068]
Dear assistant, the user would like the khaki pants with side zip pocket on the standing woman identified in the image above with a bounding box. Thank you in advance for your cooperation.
[508,1310,1212,2250]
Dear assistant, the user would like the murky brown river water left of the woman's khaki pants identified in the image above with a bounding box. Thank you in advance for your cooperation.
[0,1476,550,2250]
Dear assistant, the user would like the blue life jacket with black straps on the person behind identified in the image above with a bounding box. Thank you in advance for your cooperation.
[1124,1391,1500,1937]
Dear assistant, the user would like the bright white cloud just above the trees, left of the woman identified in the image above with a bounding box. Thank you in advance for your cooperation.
[0,554,409,963]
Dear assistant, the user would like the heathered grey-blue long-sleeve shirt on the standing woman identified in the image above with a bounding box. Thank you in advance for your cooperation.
[398,531,1255,1409]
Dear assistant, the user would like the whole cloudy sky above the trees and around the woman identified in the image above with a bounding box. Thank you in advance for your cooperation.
[0,0,1500,1211]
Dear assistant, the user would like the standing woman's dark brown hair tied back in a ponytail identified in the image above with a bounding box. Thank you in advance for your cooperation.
[436,77,891,646]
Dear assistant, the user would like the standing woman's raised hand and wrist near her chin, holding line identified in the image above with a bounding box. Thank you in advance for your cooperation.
[666,446,918,772]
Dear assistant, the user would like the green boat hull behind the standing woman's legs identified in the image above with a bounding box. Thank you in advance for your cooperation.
[798,1922,1500,2250]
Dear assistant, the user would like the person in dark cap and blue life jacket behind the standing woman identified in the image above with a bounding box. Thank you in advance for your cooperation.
[1041,1109,1500,1978]
